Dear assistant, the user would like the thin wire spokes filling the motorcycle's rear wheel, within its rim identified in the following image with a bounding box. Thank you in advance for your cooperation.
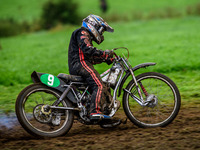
[23,86,68,133]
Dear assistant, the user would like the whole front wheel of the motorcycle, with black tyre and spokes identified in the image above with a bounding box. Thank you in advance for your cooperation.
[123,72,181,127]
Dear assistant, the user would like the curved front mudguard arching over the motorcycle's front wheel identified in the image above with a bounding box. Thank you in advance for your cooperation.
[118,63,156,97]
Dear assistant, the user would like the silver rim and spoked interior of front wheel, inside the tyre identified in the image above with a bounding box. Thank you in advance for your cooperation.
[126,75,177,126]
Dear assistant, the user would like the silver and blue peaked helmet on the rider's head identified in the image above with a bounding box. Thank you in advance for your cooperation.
[82,14,114,44]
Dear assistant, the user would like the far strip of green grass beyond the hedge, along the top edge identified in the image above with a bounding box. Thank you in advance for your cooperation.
[0,0,199,22]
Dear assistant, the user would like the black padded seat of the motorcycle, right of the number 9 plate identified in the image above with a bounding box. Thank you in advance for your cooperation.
[57,73,84,82]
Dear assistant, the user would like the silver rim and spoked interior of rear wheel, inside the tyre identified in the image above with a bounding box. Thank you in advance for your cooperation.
[22,88,69,134]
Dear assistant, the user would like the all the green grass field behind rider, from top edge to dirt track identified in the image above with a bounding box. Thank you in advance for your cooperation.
[0,0,200,112]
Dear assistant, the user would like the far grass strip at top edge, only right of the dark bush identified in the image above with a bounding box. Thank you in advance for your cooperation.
[75,0,199,16]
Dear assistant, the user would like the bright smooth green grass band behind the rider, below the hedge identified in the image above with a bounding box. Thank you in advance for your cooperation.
[0,17,200,85]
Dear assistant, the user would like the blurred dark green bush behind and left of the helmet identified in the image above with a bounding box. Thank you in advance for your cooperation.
[41,0,80,29]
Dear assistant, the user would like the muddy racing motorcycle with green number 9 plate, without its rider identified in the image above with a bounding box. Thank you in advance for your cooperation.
[15,47,181,137]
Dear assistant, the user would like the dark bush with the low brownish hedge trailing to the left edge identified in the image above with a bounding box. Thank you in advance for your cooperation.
[0,0,80,37]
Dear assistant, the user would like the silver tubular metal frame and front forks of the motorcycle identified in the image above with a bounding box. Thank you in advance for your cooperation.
[50,57,156,117]
